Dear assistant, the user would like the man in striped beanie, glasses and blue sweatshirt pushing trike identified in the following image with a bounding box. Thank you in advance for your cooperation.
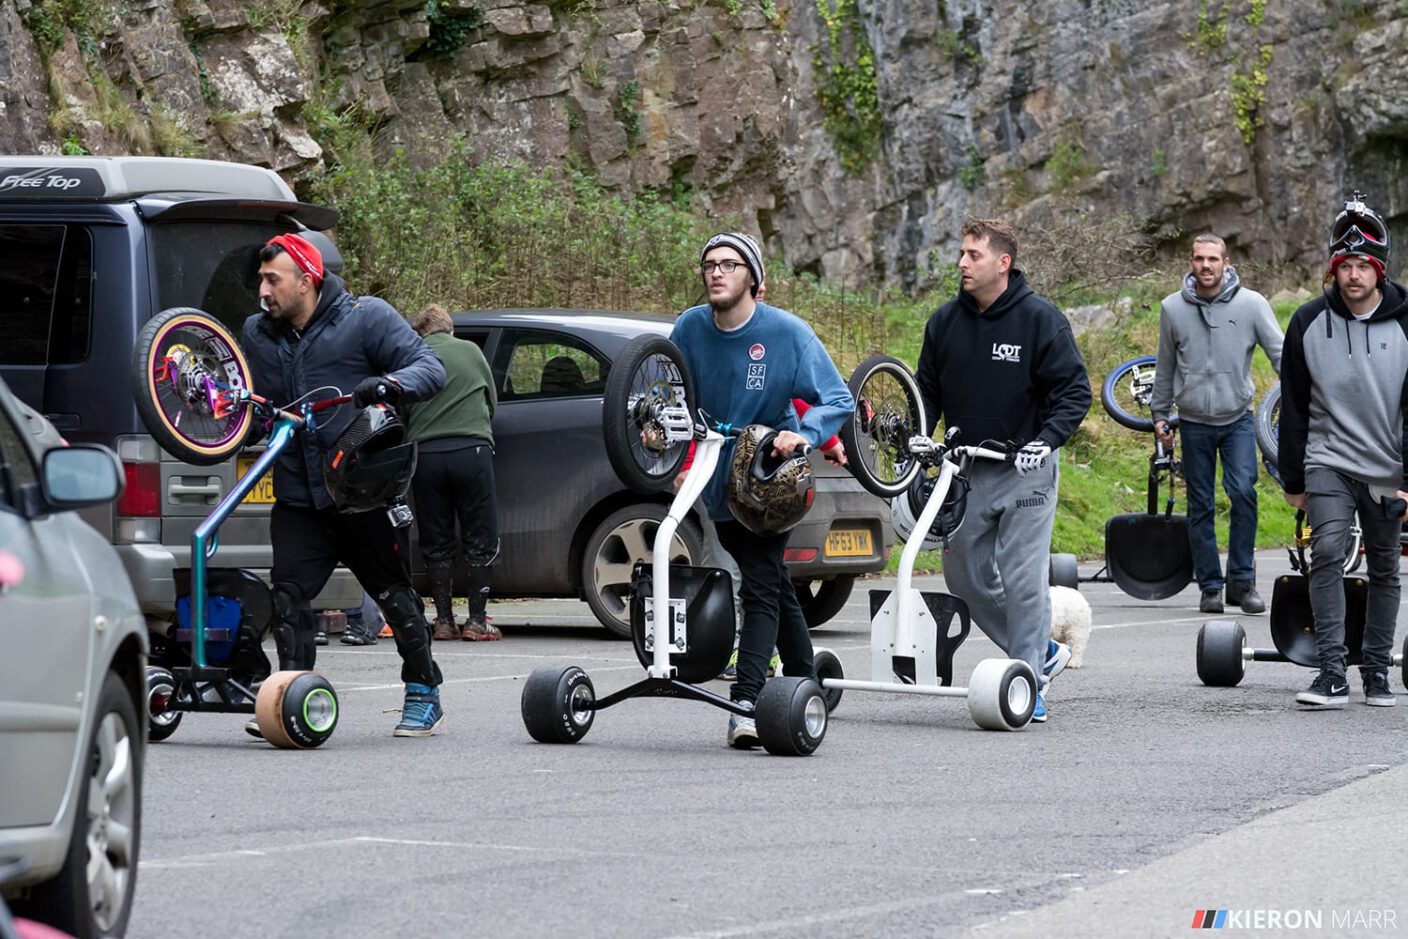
[670,232,855,749]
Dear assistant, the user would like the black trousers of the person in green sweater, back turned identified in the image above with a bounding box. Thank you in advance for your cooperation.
[411,438,498,567]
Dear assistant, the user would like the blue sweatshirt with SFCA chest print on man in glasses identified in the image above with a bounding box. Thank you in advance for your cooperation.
[670,303,855,521]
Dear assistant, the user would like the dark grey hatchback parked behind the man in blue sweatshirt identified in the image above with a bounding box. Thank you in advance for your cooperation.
[415,310,890,636]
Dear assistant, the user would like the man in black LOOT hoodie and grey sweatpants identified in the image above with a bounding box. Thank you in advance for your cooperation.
[917,218,1091,722]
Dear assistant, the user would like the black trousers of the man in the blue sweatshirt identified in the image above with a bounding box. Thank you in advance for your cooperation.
[714,519,817,701]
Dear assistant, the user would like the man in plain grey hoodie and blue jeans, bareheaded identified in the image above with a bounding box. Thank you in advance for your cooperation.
[1150,235,1281,614]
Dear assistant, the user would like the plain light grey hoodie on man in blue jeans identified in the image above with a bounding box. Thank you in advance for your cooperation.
[1150,266,1281,427]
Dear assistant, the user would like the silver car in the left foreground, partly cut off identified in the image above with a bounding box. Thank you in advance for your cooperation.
[0,382,148,939]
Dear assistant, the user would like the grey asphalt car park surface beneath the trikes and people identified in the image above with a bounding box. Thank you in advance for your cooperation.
[130,553,1408,939]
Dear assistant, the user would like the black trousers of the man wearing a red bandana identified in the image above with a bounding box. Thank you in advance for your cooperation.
[269,503,442,687]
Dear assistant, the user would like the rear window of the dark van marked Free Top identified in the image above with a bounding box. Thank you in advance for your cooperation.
[151,220,287,336]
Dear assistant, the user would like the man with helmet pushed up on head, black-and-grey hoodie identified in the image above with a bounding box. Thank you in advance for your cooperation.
[1277,191,1408,708]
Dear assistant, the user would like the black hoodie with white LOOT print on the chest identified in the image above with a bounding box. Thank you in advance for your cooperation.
[915,270,1091,448]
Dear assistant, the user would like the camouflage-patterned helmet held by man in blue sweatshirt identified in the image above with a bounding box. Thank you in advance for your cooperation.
[728,424,817,535]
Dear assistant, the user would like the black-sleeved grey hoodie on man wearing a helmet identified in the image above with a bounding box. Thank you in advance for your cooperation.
[1277,279,1408,496]
